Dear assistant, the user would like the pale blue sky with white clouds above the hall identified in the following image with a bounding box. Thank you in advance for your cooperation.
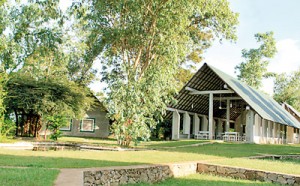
[79,0,300,95]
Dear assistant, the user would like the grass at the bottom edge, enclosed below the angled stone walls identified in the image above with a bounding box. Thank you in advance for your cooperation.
[128,174,274,186]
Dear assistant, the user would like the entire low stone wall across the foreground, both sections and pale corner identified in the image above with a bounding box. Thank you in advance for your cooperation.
[83,162,300,186]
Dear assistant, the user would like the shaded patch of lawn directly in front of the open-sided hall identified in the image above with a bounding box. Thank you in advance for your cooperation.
[156,143,300,158]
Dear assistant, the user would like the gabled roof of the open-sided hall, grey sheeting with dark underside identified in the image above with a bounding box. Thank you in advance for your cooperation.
[170,63,300,128]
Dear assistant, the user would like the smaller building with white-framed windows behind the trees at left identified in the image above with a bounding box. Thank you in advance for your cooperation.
[60,99,110,138]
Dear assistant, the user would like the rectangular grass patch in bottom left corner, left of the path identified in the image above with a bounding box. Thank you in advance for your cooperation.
[0,168,59,186]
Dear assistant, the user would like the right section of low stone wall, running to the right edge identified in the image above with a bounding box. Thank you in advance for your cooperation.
[197,163,300,185]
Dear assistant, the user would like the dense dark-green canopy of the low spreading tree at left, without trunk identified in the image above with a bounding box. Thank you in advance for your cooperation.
[6,74,93,117]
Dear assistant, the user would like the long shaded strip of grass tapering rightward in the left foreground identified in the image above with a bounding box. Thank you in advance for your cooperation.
[0,155,147,168]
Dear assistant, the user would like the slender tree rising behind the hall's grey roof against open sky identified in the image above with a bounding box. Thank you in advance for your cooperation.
[235,32,277,89]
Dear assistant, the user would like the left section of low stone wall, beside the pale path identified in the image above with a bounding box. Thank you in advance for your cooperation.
[83,165,173,186]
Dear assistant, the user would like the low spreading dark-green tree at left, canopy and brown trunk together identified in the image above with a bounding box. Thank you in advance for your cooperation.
[5,73,93,137]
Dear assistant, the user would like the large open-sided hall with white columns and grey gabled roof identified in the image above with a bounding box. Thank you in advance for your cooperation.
[167,63,300,144]
